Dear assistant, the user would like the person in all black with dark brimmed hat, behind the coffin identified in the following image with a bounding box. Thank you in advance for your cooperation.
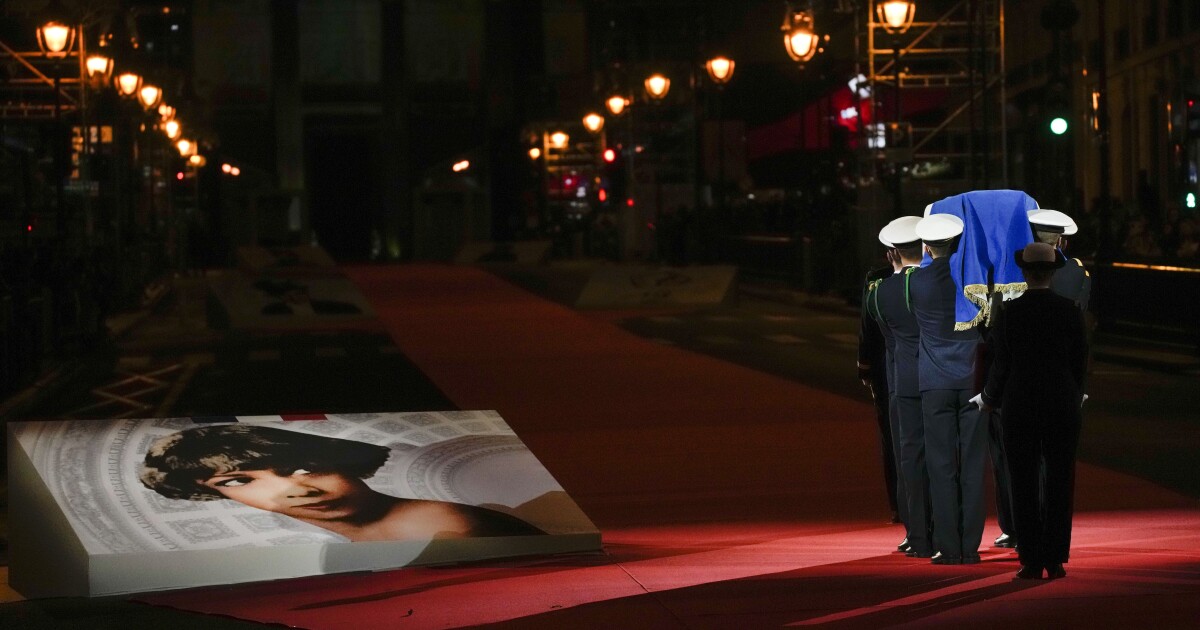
[974,242,1087,580]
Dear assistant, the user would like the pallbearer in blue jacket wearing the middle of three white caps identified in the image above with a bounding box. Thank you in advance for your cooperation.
[908,214,988,564]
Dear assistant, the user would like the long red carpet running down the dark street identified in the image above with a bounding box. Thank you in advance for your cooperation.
[143,266,1200,629]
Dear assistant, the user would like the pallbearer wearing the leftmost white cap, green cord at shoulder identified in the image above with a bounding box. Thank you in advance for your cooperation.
[866,216,932,558]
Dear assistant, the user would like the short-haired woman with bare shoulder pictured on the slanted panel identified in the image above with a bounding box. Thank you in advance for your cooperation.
[139,425,545,541]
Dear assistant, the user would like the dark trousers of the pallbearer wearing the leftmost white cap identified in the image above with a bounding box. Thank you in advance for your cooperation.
[893,396,932,553]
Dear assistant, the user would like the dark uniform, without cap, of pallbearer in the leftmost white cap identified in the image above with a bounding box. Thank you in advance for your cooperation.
[868,266,932,558]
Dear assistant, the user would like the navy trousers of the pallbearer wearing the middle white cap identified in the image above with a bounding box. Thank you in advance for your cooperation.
[920,389,988,559]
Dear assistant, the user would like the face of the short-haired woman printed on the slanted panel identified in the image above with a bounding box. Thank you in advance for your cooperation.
[202,468,371,521]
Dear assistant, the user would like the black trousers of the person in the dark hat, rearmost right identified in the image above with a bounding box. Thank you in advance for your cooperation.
[1003,407,1081,566]
